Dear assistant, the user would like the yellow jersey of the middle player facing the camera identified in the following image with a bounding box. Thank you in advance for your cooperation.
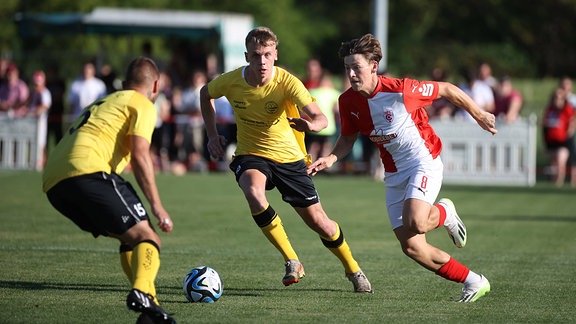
[208,67,314,163]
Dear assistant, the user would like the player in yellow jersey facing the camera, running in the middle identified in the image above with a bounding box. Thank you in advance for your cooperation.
[200,27,372,292]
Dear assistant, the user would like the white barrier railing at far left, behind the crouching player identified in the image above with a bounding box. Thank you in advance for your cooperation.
[0,114,41,170]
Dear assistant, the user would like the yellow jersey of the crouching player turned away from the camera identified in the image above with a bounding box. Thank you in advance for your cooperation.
[42,90,156,192]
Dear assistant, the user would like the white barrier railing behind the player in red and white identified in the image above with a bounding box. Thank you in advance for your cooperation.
[431,116,537,186]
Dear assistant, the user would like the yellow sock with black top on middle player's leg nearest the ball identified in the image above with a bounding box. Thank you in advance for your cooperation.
[252,205,298,261]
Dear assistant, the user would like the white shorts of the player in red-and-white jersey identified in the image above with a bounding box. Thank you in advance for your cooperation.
[384,156,444,230]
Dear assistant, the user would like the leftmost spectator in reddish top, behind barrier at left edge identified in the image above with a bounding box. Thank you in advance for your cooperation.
[0,63,30,117]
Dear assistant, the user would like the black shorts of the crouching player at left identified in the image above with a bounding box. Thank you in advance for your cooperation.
[46,172,149,237]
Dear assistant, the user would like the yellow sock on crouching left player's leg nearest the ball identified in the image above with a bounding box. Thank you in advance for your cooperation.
[131,241,160,304]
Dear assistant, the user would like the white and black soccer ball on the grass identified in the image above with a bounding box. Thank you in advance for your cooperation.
[182,266,224,303]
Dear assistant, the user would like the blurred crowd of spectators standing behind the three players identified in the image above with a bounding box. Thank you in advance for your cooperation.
[0,51,576,187]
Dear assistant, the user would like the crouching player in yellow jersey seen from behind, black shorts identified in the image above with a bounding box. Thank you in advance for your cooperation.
[43,57,175,323]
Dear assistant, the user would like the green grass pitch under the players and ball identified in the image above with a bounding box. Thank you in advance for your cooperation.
[0,171,576,323]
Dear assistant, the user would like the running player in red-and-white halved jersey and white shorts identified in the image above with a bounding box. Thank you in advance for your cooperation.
[308,34,497,302]
